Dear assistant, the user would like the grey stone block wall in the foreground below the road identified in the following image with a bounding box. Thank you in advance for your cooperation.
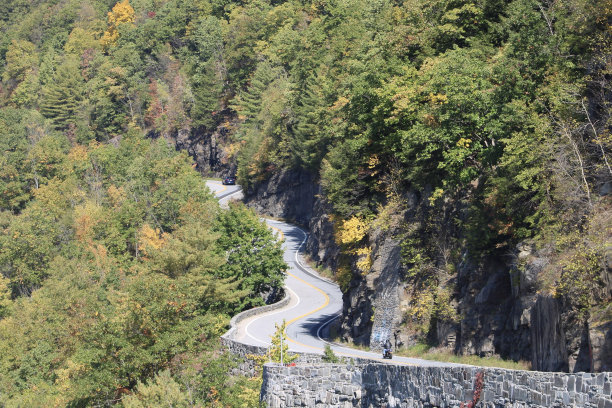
[261,363,612,408]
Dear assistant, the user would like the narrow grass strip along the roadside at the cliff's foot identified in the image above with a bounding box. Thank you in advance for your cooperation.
[395,344,531,370]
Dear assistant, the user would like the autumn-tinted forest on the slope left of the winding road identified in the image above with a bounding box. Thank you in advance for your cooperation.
[0,1,286,407]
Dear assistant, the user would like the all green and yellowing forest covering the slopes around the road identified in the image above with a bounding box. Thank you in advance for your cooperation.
[0,0,612,406]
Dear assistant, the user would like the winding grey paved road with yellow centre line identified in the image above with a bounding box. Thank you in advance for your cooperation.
[206,181,457,366]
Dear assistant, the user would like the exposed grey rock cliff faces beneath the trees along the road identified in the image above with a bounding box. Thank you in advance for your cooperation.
[211,167,612,372]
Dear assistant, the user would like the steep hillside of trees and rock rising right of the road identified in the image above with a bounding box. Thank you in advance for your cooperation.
[222,0,612,371]
